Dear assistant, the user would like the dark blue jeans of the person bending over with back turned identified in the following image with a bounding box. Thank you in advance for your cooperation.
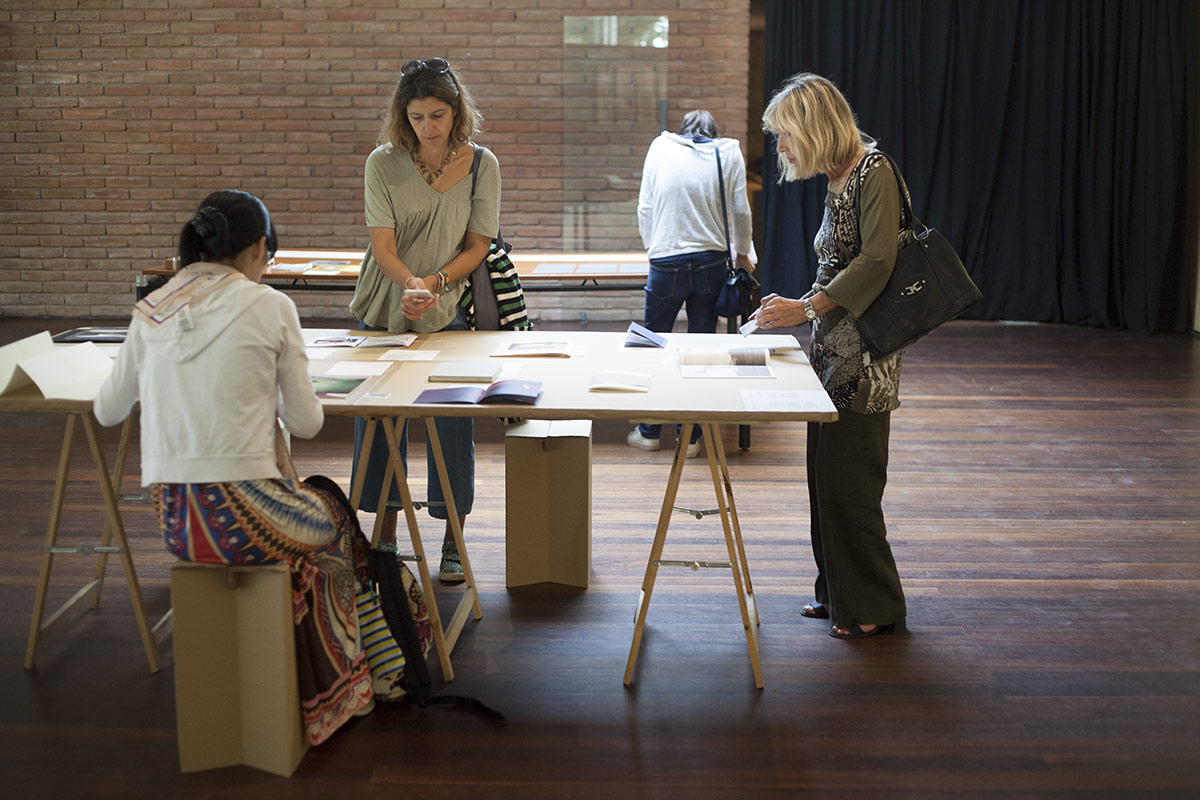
[637,249,727,443]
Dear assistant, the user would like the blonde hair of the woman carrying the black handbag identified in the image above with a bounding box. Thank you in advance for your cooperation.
[762,72,863,182]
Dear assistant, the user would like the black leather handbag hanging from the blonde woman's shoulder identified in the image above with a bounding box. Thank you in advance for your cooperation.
[856,154,983,359]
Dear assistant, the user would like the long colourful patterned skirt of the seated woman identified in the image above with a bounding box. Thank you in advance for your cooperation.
[151,479,372,745]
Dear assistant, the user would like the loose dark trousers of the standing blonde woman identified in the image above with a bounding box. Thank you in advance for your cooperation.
[808,410,907,627]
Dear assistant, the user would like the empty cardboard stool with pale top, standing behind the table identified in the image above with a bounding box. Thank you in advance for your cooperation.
[504,420,592,588]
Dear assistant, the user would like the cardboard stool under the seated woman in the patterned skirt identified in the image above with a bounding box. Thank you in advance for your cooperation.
[170,561,308,777]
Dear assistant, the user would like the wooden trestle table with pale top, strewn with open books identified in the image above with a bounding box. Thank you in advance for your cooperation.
[305,330,838,688]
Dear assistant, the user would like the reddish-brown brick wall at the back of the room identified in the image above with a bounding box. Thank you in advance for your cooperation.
[0,0,750,319]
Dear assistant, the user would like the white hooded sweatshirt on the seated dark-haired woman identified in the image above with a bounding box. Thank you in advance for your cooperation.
[94,261,324,486]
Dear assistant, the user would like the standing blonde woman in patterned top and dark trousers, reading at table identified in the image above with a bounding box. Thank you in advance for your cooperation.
[754,73,911,639]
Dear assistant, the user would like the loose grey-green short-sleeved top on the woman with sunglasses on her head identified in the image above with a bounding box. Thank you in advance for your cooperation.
[350,144,500,333]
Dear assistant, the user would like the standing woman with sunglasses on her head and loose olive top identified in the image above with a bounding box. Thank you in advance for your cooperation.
[350,59,500,582]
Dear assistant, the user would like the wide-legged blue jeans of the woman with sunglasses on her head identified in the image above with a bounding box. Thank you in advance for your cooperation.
[350,309,475,519]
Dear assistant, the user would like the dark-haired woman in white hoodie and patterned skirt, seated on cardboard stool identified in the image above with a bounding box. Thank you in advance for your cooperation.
[94,191,398,744]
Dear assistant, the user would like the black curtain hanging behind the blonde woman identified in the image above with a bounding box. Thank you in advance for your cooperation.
[762,0,1200,332]
